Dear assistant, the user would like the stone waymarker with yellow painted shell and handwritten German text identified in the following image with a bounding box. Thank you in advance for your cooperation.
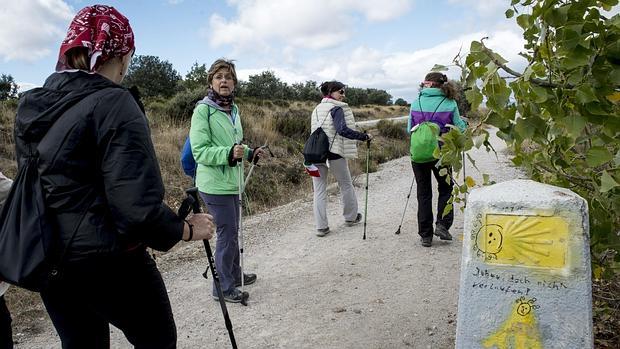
[456,180,593,349]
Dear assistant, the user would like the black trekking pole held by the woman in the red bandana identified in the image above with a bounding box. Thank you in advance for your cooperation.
[179,187,237,349]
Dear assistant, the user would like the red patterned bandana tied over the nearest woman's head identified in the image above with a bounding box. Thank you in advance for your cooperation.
[56,5,134,71]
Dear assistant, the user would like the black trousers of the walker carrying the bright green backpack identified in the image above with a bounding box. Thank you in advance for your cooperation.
[411,160,454,237]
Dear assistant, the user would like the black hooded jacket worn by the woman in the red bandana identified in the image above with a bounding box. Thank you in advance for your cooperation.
[15,71,183,260]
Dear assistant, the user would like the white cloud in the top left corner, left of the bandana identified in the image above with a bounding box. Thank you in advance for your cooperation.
[0,0,74,61]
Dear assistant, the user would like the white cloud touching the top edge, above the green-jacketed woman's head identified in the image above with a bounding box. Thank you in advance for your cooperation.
[203,0,413,51]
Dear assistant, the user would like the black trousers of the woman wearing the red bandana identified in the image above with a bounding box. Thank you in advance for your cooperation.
[41,249,177,349]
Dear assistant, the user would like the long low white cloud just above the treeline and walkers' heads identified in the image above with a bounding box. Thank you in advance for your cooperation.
[239,30,525,100]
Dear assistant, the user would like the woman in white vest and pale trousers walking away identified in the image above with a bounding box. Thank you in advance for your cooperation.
[310,81,372,236]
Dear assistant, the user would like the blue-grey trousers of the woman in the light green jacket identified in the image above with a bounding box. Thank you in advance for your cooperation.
[200,192,241,295]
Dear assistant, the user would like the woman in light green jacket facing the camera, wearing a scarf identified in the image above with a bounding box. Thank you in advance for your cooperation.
[189,59,263,303]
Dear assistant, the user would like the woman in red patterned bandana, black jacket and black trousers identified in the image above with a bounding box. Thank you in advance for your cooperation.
[15,5,213,348]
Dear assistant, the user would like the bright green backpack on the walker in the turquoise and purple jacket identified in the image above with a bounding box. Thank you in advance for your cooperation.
[409,97,446,163]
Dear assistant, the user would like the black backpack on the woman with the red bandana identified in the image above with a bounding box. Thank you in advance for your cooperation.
[0,88,112,292]
